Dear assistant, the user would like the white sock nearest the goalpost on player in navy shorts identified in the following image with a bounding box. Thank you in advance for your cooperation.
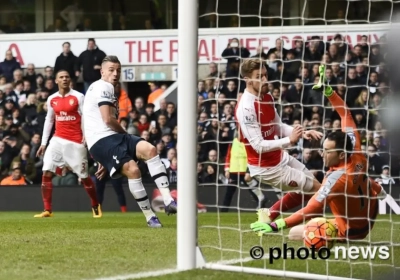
[146,155,174,205]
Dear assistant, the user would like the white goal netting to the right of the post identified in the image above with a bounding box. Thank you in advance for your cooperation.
[198,0,400,279]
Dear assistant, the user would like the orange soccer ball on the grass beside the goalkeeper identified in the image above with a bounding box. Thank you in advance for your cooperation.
[304,218,337,250]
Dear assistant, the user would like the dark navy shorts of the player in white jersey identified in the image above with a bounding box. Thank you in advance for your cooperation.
[90,134,144,179]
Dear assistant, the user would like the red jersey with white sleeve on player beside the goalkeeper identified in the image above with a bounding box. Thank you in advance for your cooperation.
[235,91,282,167]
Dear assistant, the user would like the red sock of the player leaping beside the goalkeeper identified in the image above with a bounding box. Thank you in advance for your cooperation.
[269,192,312,221]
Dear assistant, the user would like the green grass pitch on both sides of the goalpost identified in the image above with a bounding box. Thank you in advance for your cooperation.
[0,212,400,280]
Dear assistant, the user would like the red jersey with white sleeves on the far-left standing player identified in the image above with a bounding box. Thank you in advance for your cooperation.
[42,90,84,145]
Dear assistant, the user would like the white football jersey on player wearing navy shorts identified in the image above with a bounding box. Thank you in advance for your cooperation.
[83,80,118,149]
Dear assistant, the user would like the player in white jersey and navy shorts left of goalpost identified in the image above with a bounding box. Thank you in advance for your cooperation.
[83,56,177,227]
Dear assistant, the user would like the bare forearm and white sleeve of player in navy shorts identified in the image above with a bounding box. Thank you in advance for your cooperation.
[97,87,126,134]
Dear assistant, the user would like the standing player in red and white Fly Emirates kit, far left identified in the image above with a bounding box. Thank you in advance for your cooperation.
[34,70,102,218]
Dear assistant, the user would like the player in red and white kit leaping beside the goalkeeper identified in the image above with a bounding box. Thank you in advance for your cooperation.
[235,58,322,222]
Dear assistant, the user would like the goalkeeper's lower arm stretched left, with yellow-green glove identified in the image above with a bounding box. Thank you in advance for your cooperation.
[250,170,346,233]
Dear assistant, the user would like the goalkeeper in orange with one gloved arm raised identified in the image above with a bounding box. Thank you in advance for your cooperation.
[251,65,386,240]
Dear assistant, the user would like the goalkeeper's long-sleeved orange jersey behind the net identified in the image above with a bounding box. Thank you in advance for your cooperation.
[285,93,380,239]
